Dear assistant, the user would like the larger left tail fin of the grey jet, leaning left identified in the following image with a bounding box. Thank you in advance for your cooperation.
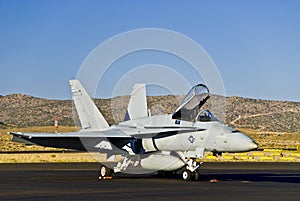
[70,80,109,130]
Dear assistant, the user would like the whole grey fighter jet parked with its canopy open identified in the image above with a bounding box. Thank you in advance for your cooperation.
[10,80,257,181]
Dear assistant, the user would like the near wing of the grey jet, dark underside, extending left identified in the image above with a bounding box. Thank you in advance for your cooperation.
[9,126,205,152]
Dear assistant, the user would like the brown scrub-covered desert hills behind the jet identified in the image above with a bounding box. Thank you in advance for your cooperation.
[0,94,300,132]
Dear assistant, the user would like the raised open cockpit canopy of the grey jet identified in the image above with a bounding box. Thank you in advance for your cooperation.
[172,84,209,121]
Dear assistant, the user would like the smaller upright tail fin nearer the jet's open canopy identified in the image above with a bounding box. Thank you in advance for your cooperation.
[125,83,148,120]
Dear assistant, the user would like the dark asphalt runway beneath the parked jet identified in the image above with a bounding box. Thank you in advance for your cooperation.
[0,163,300,201]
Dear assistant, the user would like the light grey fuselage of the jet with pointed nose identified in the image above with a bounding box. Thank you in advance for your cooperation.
[118,115,257,152]
